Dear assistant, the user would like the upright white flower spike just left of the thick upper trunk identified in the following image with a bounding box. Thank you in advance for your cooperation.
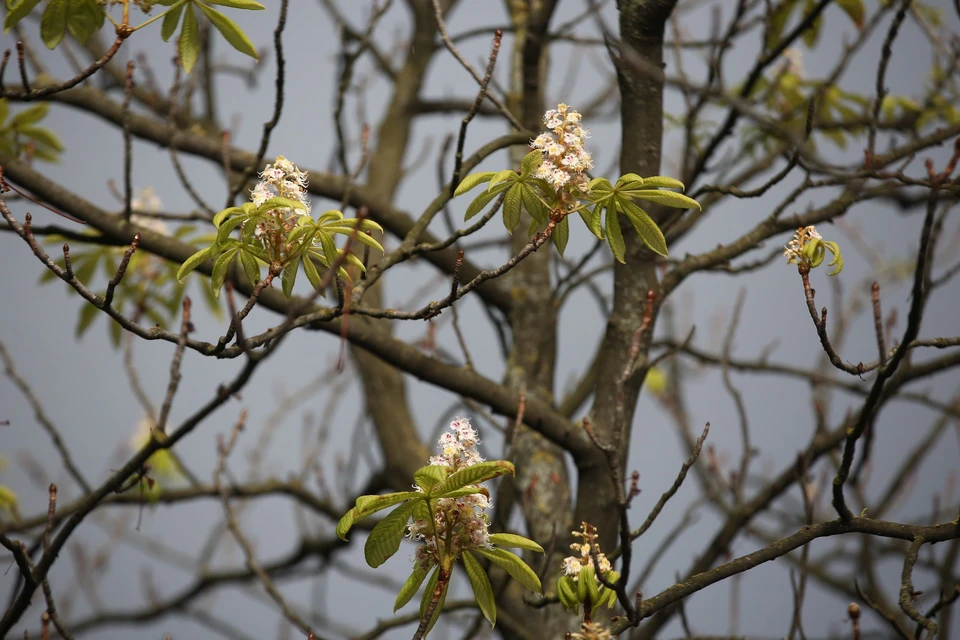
[530,104,593,199]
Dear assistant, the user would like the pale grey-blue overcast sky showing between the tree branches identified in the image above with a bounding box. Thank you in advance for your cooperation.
[0,0,960,640]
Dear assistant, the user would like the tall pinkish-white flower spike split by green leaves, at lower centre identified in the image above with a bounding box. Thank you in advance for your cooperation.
[407,418,493,566]
